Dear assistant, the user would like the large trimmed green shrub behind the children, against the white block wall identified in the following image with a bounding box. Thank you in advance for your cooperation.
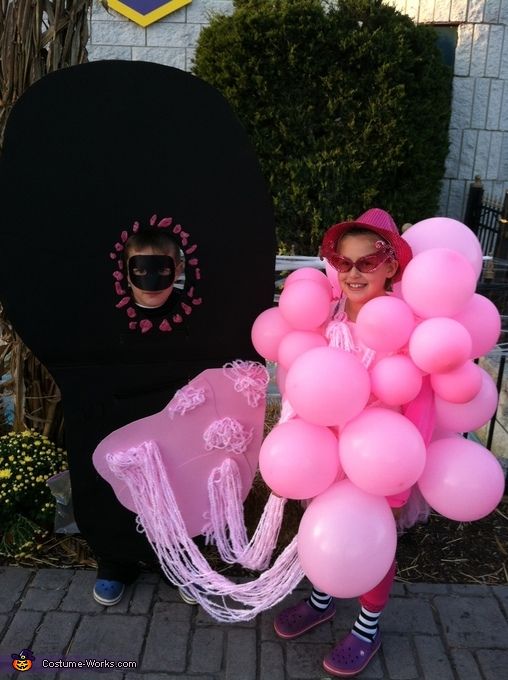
[194,0,451,254]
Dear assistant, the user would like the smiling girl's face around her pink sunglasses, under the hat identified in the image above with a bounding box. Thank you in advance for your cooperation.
[338,234,399,305]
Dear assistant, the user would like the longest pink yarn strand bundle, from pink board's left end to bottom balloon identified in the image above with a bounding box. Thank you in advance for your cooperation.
[106,441,303,622]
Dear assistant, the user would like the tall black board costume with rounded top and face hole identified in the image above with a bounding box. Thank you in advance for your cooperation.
[0,61,275,577]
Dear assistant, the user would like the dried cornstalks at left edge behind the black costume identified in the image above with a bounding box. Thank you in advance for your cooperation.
[0,0,93,439]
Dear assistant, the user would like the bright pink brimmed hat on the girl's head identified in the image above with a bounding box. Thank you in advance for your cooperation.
[320,208,413,281]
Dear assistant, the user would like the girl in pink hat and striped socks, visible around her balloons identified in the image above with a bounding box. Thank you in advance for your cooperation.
[274,208,412,677]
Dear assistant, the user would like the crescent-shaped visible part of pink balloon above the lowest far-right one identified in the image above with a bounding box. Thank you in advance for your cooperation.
[435,368,498,432]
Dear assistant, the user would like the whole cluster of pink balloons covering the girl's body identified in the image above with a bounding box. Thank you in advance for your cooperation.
[252,218,504,597]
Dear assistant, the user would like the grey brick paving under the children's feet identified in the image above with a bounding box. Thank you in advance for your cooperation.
[0,567,508,680]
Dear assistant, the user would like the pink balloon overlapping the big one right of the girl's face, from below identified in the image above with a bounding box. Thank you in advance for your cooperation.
[409,318,472,373]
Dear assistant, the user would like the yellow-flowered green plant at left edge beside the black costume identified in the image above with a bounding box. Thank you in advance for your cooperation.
[0,430,66,528]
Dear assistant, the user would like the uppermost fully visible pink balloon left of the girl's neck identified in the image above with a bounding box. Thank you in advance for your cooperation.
[279,279,331,331]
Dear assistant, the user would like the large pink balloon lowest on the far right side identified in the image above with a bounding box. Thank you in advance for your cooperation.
[418,437,505,522]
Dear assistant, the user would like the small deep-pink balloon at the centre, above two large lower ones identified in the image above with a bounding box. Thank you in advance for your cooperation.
[370,354,422,406]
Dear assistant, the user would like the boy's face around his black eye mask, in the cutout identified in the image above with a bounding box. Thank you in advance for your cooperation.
[128,246,183,308]
